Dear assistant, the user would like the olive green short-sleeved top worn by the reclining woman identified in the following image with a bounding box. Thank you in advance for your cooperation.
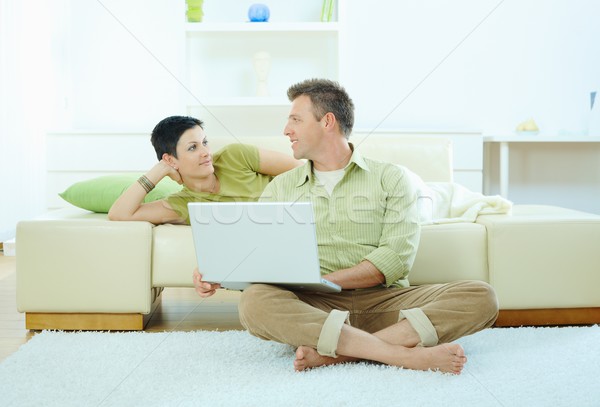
[166,143,273,225]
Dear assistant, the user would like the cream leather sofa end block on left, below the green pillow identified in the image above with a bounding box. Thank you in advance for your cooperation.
[16,217,153,314]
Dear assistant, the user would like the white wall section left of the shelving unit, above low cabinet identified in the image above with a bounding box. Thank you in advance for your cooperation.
[63,0,185,131]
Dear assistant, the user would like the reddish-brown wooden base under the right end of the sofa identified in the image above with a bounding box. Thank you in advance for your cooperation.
[494,307,600,327]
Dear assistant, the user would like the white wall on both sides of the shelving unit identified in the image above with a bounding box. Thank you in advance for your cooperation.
[50,0,600,134]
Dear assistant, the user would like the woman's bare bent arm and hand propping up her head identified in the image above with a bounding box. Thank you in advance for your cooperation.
[108,160,185,225]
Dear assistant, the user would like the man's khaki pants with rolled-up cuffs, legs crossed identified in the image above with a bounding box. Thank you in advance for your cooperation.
[239,281,498,356]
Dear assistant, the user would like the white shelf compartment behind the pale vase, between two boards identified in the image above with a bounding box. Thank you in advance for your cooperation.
[185,22,339,103]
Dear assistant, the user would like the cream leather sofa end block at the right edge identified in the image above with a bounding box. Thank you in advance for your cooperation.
[477,205,600,309]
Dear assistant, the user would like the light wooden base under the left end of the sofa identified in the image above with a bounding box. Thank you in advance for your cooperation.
[25,289,162,331]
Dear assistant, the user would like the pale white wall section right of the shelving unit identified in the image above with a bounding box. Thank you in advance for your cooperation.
[341,0,600,134]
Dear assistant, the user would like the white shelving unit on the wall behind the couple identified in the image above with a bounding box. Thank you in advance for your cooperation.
[185,0,340,139]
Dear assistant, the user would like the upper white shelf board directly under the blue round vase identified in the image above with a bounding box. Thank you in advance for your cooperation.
[185,22,338,35]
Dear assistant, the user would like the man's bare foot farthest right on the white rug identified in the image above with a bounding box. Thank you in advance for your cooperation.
[398,343,467,374]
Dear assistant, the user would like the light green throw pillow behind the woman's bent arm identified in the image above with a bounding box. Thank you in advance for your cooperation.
[58,174,181,213]
